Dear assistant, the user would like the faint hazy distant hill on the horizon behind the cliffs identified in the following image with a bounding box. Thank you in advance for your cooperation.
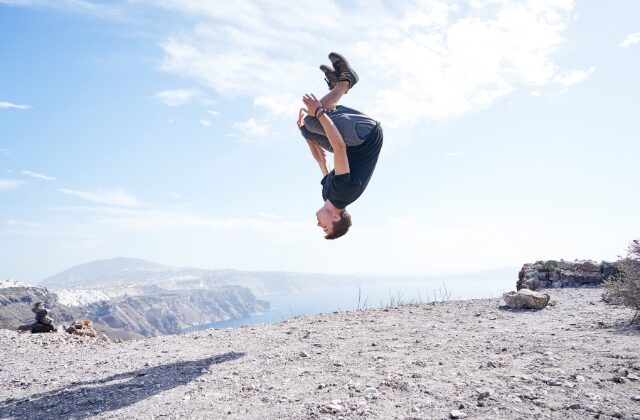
[41,257,352,294]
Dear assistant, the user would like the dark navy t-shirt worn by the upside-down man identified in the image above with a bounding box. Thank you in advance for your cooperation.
[321,124,382,209]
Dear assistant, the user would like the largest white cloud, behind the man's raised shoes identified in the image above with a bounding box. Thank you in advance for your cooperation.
[148,0,574,126]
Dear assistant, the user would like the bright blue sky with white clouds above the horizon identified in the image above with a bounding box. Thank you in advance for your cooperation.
[0,0,640,282]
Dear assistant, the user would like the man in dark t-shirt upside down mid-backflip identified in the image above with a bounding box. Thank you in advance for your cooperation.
[298,52,382,239]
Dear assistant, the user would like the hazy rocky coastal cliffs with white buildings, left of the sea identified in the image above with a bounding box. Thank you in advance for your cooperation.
[0,286,269,339]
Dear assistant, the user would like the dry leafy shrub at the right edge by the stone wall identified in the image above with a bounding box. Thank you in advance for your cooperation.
[605,240,640,323]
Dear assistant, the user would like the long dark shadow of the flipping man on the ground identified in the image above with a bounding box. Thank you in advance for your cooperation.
[0,352,245,419]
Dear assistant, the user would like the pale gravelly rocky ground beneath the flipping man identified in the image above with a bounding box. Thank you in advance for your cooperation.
[0,289,640,419]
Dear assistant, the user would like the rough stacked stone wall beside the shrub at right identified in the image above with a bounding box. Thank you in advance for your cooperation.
[516,260,619,290]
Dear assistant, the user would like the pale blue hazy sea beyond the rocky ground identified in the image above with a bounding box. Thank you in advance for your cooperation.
[185,267,519,332]
